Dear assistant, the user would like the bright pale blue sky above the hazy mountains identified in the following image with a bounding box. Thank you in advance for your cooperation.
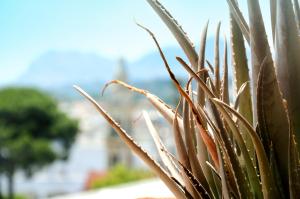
[0,0,268,84]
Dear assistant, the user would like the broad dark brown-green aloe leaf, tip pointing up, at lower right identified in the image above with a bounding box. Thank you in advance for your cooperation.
[257,52,289,193]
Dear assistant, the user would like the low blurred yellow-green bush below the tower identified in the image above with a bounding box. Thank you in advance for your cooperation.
[91,165,153,189]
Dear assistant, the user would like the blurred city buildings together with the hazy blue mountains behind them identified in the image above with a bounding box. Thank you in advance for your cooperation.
[0,32,227,198]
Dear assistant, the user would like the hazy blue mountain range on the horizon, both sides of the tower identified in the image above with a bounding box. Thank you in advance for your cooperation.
[16,38,223,97]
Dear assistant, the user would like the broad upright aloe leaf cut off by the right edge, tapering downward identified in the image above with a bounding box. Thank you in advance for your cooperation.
[275,0,300,150]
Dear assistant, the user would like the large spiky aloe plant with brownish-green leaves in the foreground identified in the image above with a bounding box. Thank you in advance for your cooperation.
[75,0,300,199]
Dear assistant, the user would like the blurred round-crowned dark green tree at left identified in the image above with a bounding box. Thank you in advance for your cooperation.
[0,88,78,199]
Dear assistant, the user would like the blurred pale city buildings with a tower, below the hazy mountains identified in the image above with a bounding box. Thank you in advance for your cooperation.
[1,59,178,198]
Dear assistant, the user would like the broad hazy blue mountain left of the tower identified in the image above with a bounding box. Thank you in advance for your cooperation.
[17,51,114,88]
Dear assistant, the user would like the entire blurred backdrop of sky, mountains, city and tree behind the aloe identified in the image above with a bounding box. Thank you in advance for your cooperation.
[0,0,270,198]
